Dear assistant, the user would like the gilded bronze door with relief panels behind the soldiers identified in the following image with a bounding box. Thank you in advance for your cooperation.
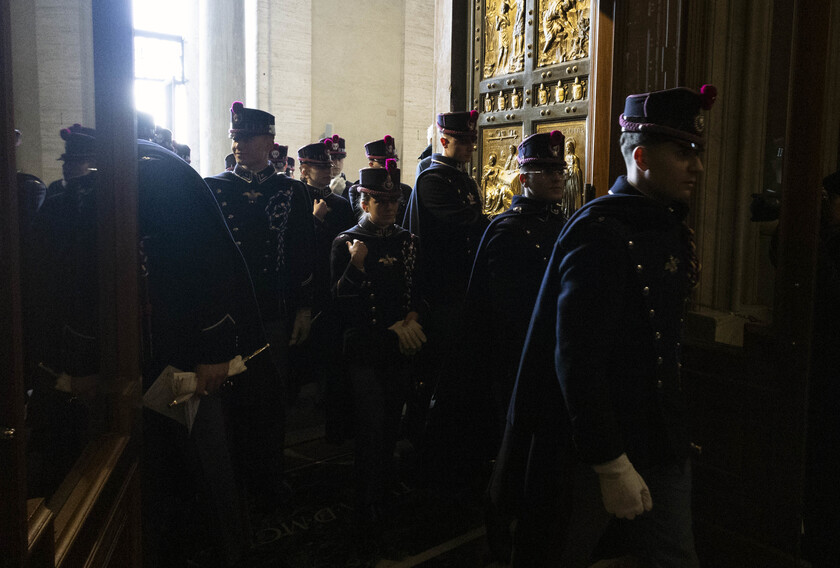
[471,0,597,216]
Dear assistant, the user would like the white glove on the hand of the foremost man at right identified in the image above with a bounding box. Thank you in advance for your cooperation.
[592,454,653,519]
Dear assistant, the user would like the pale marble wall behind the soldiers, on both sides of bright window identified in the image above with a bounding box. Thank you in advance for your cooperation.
[11,0,435,184]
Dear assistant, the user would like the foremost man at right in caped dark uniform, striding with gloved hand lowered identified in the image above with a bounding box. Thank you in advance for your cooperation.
[491,86,716,567]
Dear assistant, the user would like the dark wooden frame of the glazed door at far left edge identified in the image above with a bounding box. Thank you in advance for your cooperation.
[0,0,140,568]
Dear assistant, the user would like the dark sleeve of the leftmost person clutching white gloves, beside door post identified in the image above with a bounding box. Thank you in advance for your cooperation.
[138,158,262,368]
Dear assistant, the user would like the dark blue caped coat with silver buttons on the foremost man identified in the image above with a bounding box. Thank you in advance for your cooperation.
[491,176,689,524]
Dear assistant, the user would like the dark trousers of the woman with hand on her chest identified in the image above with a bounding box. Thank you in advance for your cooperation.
[349,364,407,507]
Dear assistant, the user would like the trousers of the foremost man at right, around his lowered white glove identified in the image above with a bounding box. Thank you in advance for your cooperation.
[512,461,699,568]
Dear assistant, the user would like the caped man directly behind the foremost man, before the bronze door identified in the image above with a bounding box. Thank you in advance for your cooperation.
[467,130,566,457]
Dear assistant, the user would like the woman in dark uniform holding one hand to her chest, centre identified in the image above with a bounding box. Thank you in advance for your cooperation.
[332,160,425,523]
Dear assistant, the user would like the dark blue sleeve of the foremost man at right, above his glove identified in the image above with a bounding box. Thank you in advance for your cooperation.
[555,223,627,464]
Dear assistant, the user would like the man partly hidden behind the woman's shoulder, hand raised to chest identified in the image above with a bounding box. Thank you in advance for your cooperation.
[292,142,355,442]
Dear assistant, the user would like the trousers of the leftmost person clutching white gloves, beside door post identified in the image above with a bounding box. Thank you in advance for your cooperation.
[142,394,248,567]
